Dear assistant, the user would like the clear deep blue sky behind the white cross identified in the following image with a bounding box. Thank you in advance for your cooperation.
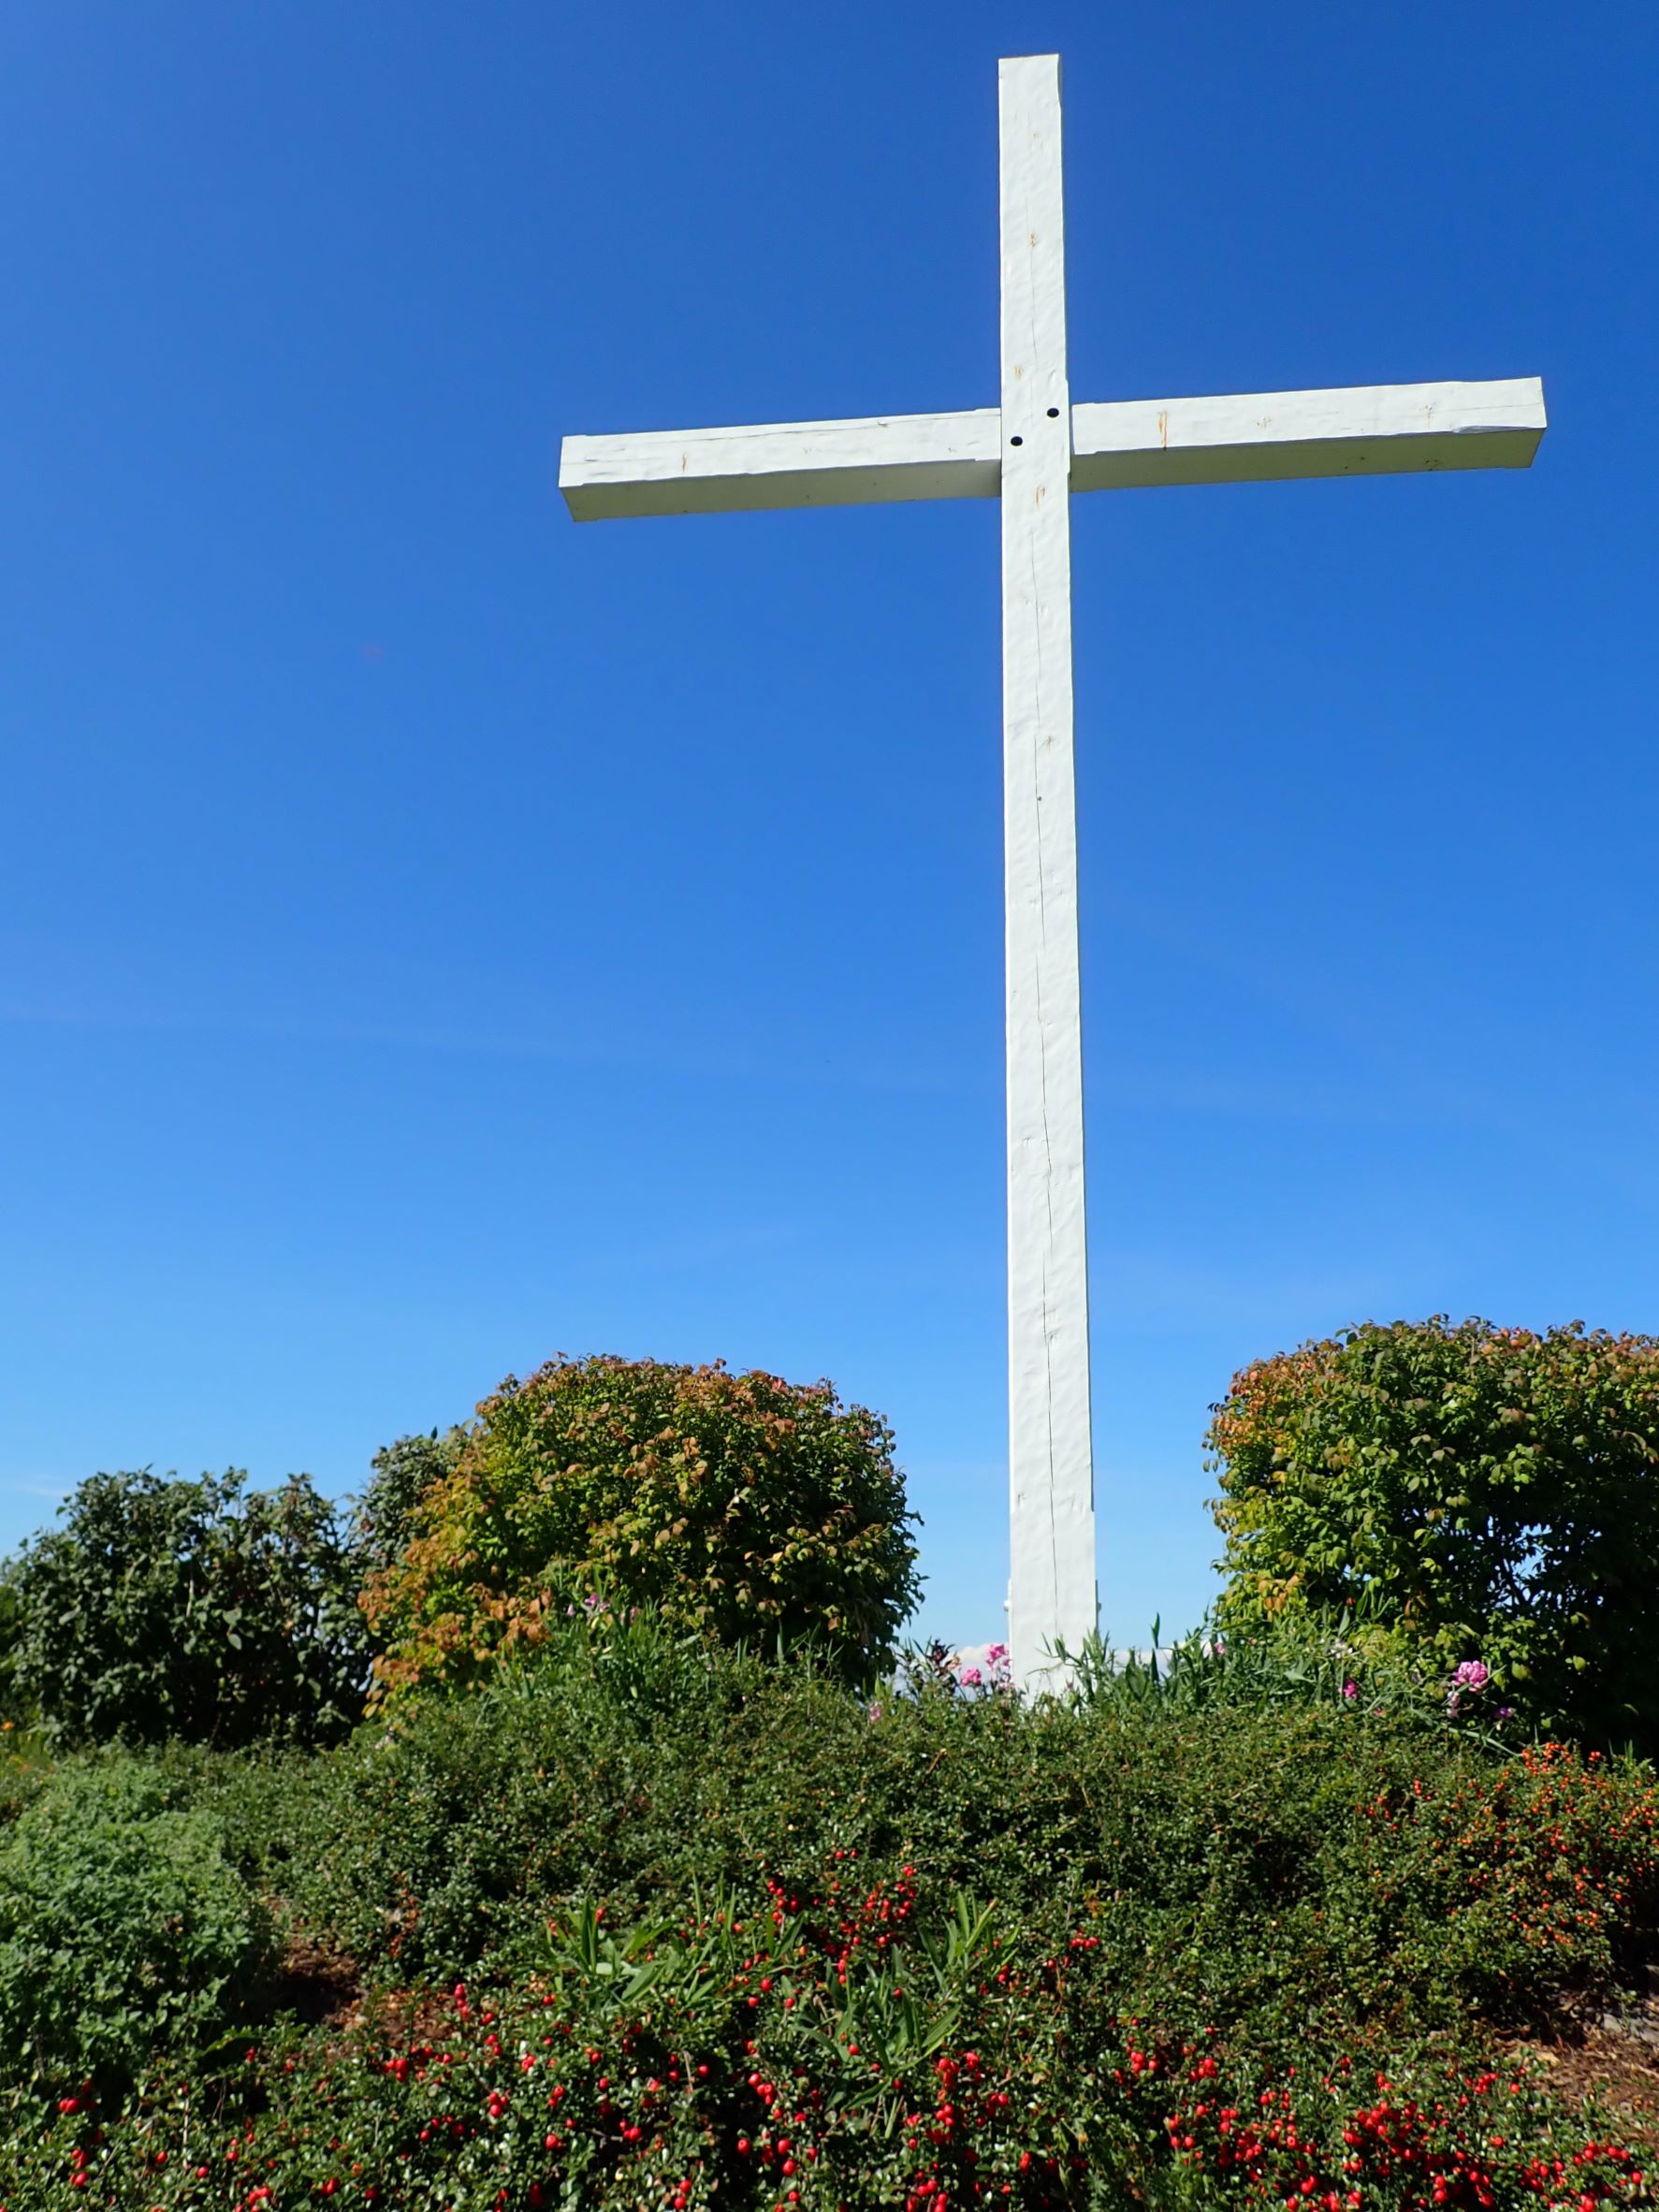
[0,0,1659,1639]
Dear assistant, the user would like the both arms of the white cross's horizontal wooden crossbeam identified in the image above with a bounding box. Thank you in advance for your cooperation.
[560,376,1544,522]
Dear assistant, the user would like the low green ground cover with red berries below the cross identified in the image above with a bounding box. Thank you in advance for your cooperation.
[0,1622,1659,2212]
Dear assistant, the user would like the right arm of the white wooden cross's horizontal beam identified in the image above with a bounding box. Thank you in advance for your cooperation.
[1070,376,1544,491]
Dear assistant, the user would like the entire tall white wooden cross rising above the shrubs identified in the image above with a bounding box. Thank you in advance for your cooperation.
[560,53,1544,1688]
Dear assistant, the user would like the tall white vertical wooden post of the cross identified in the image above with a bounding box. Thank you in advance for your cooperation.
[997,53,1095,1685]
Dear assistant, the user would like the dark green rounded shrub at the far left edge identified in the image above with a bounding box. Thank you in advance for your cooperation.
[13,1471,367,1745]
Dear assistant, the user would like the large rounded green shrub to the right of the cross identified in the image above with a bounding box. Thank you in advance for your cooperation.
[1210,1317,1659,1750]
